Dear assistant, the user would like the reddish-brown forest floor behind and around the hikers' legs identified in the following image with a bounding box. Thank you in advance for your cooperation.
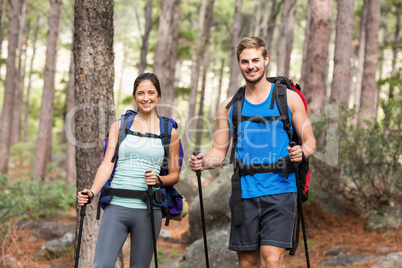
[0,202,402,268]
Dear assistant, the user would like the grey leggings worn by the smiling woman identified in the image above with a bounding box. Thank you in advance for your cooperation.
[94,205,162,268]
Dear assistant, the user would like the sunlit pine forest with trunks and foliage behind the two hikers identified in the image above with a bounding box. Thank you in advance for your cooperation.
[0,0,402,267]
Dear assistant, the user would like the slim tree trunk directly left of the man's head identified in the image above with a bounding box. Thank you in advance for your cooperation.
[228,0,242,97]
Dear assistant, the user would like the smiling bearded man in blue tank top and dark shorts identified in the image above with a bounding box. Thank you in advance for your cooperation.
[190,37,316,268]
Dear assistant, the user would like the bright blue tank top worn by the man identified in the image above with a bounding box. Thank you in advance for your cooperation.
[229,84,297,198]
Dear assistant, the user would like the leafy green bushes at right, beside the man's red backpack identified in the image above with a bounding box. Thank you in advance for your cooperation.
[311,98,402,214]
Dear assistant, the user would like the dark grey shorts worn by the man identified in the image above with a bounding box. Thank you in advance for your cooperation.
[229,193,297,251]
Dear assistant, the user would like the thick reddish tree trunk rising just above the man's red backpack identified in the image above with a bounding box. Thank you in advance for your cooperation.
[301,0,333,111]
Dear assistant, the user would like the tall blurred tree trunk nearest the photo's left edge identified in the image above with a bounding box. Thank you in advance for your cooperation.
[10,0,27,145]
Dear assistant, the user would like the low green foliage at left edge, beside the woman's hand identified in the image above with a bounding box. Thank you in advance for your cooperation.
[0,174,75,238]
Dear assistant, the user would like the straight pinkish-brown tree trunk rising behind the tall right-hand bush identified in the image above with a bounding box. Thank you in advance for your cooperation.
[359,0,381,123]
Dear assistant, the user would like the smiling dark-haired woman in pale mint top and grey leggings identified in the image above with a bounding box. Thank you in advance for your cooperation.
[77,73,180,268]
